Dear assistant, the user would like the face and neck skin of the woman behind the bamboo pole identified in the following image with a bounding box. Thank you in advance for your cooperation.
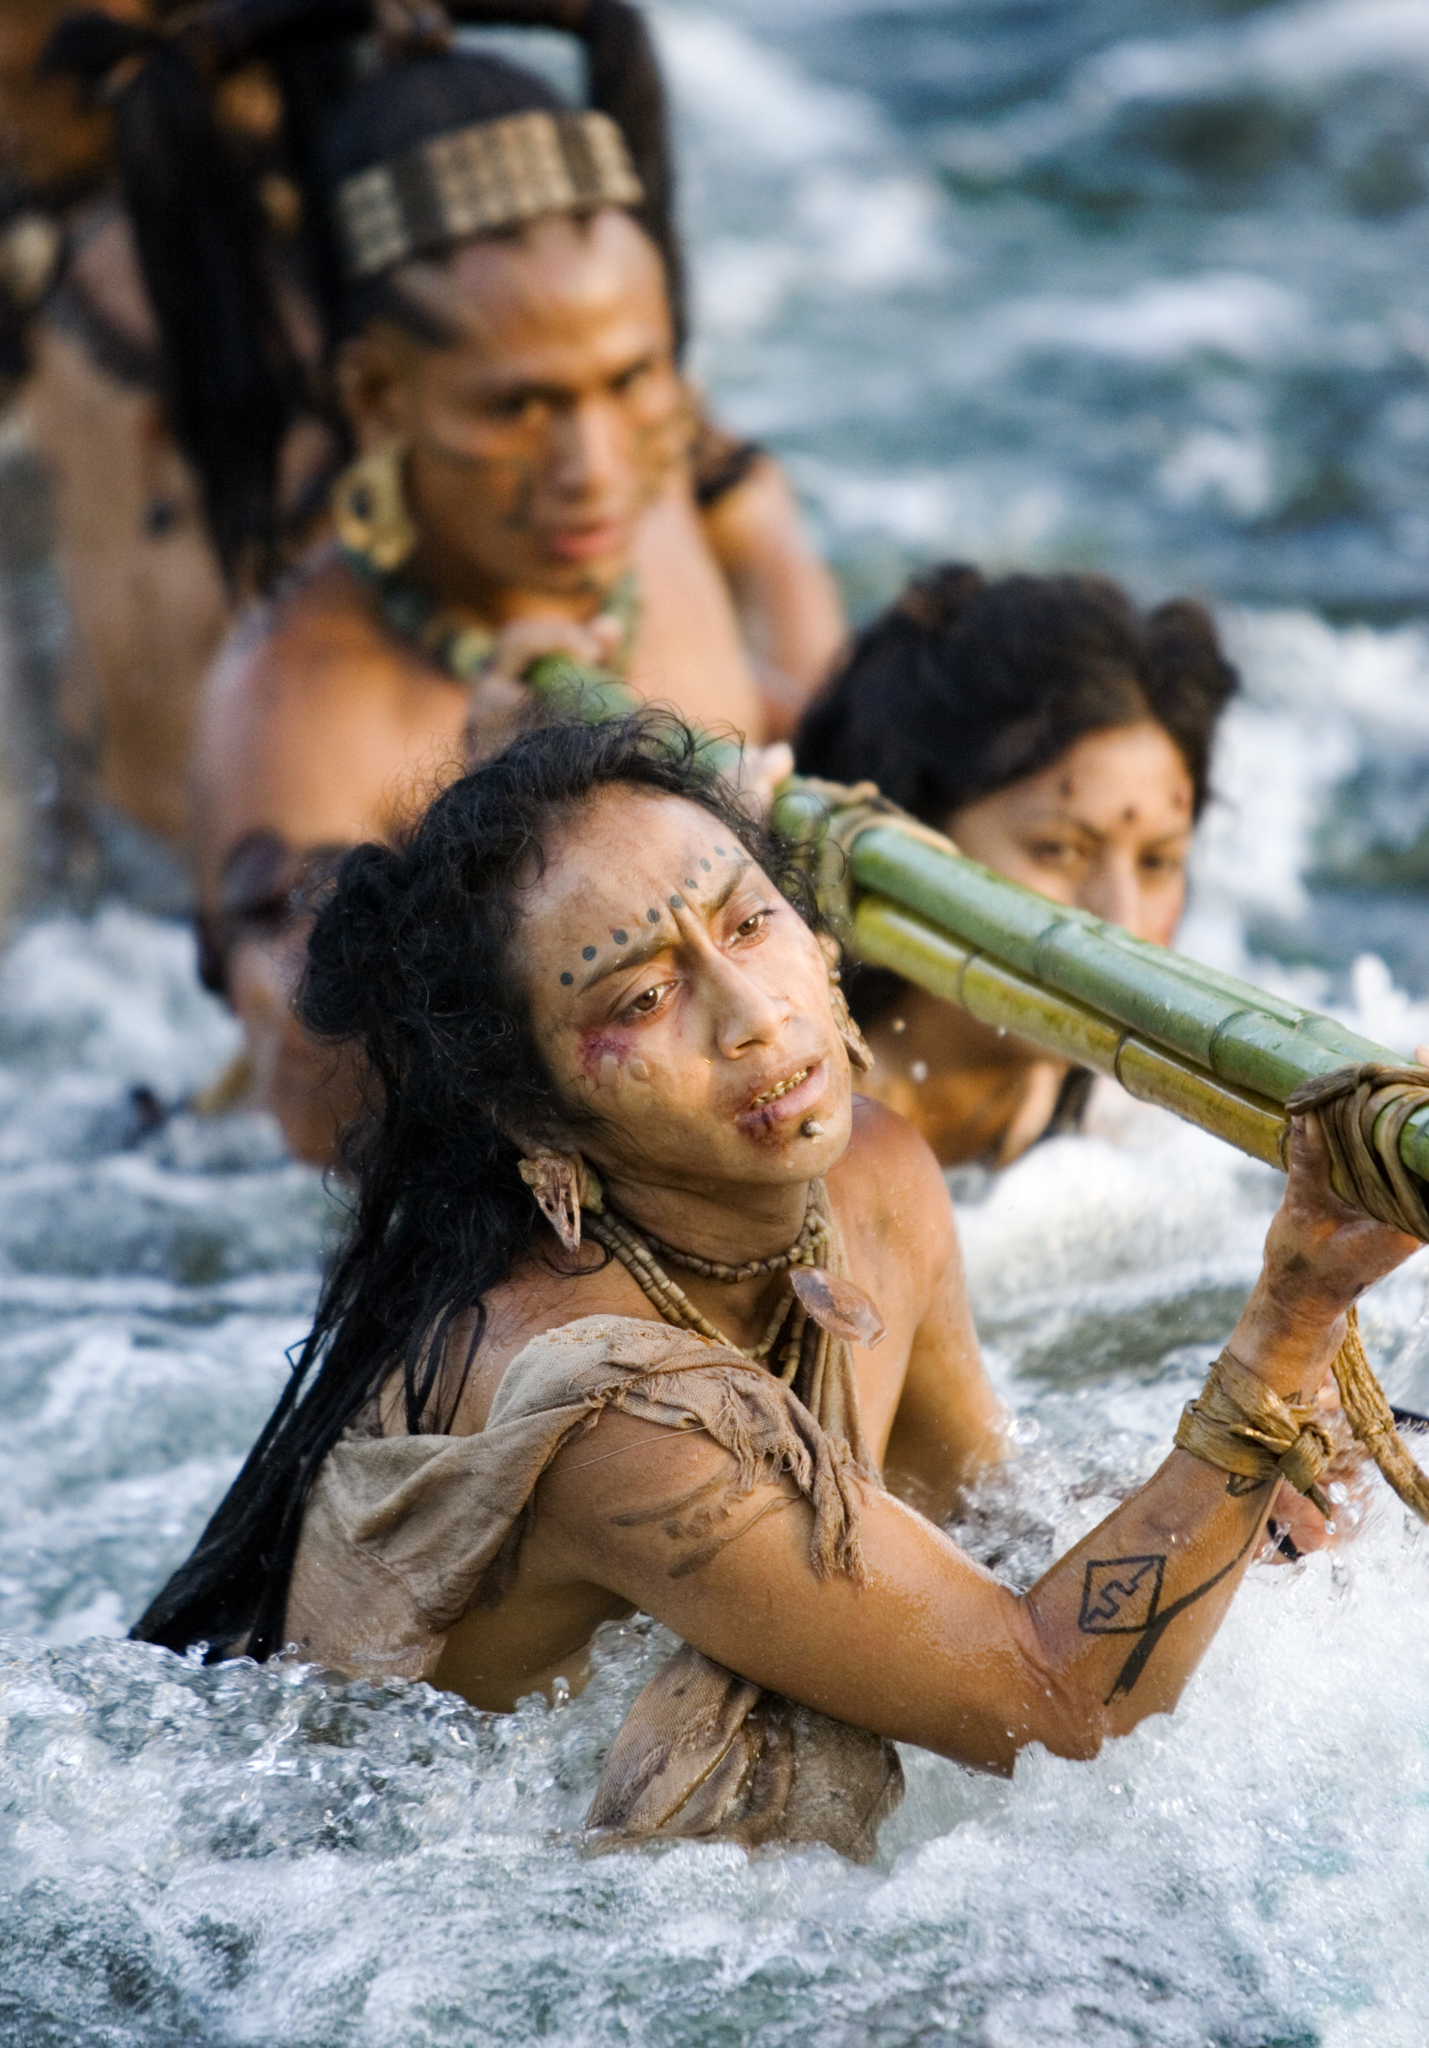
[868,719,1192,1165]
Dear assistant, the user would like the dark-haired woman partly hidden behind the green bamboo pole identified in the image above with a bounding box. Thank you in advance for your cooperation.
[796,563,1237,1165]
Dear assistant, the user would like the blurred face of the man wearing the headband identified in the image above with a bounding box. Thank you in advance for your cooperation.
[348,207,688,596]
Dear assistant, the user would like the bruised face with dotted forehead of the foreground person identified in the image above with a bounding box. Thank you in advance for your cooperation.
[520,788,852,1192]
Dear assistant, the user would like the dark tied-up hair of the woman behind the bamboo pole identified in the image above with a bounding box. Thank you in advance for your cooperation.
[794,563,1239,1024]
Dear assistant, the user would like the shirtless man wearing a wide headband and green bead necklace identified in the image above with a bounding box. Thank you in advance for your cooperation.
[63,0,839,1157]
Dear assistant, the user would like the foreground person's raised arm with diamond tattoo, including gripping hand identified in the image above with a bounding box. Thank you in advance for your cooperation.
[540,1128,1415,1772]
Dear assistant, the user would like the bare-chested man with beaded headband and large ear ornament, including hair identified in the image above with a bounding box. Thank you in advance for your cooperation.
[45,0,843,1159]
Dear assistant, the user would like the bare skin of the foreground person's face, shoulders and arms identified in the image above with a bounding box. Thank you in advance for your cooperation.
[333,791,1413,1769]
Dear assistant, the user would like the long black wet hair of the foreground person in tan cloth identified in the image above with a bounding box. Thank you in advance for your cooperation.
[133,713,817,1659]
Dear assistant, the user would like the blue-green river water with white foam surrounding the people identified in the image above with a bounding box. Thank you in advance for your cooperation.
[0,0,1429,2048]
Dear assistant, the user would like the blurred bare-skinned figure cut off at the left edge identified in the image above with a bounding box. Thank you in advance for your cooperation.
[0,0,229,911]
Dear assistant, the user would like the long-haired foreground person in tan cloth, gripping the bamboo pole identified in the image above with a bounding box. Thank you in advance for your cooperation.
[135,719,1415,1853]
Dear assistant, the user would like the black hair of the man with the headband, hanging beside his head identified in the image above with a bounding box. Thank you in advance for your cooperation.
[41,0,686,582]
